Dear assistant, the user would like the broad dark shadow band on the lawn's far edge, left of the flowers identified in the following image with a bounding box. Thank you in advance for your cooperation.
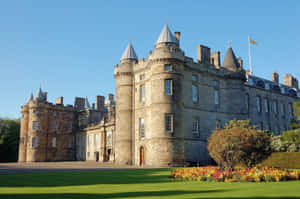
[0,169,174,187]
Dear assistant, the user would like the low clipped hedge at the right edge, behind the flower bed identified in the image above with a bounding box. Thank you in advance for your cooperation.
[261,152,300,169]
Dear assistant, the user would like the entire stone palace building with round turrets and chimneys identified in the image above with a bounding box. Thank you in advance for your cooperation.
[19,22,300,166]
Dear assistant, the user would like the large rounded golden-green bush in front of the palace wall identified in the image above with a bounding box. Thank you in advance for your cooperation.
[207,120,271,169]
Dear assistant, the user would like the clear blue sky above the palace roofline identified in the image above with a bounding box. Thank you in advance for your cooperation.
[0,0,300,118]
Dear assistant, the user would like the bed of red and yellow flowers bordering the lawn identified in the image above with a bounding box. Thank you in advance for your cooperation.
[171,166,300,182]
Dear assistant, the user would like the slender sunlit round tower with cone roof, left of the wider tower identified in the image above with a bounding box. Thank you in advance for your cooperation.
[114,43,137,164]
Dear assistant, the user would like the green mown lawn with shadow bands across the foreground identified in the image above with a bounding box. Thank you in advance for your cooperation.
[0,169,300,199]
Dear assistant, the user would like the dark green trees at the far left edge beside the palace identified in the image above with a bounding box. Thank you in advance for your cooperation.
[0,119,20,162]
